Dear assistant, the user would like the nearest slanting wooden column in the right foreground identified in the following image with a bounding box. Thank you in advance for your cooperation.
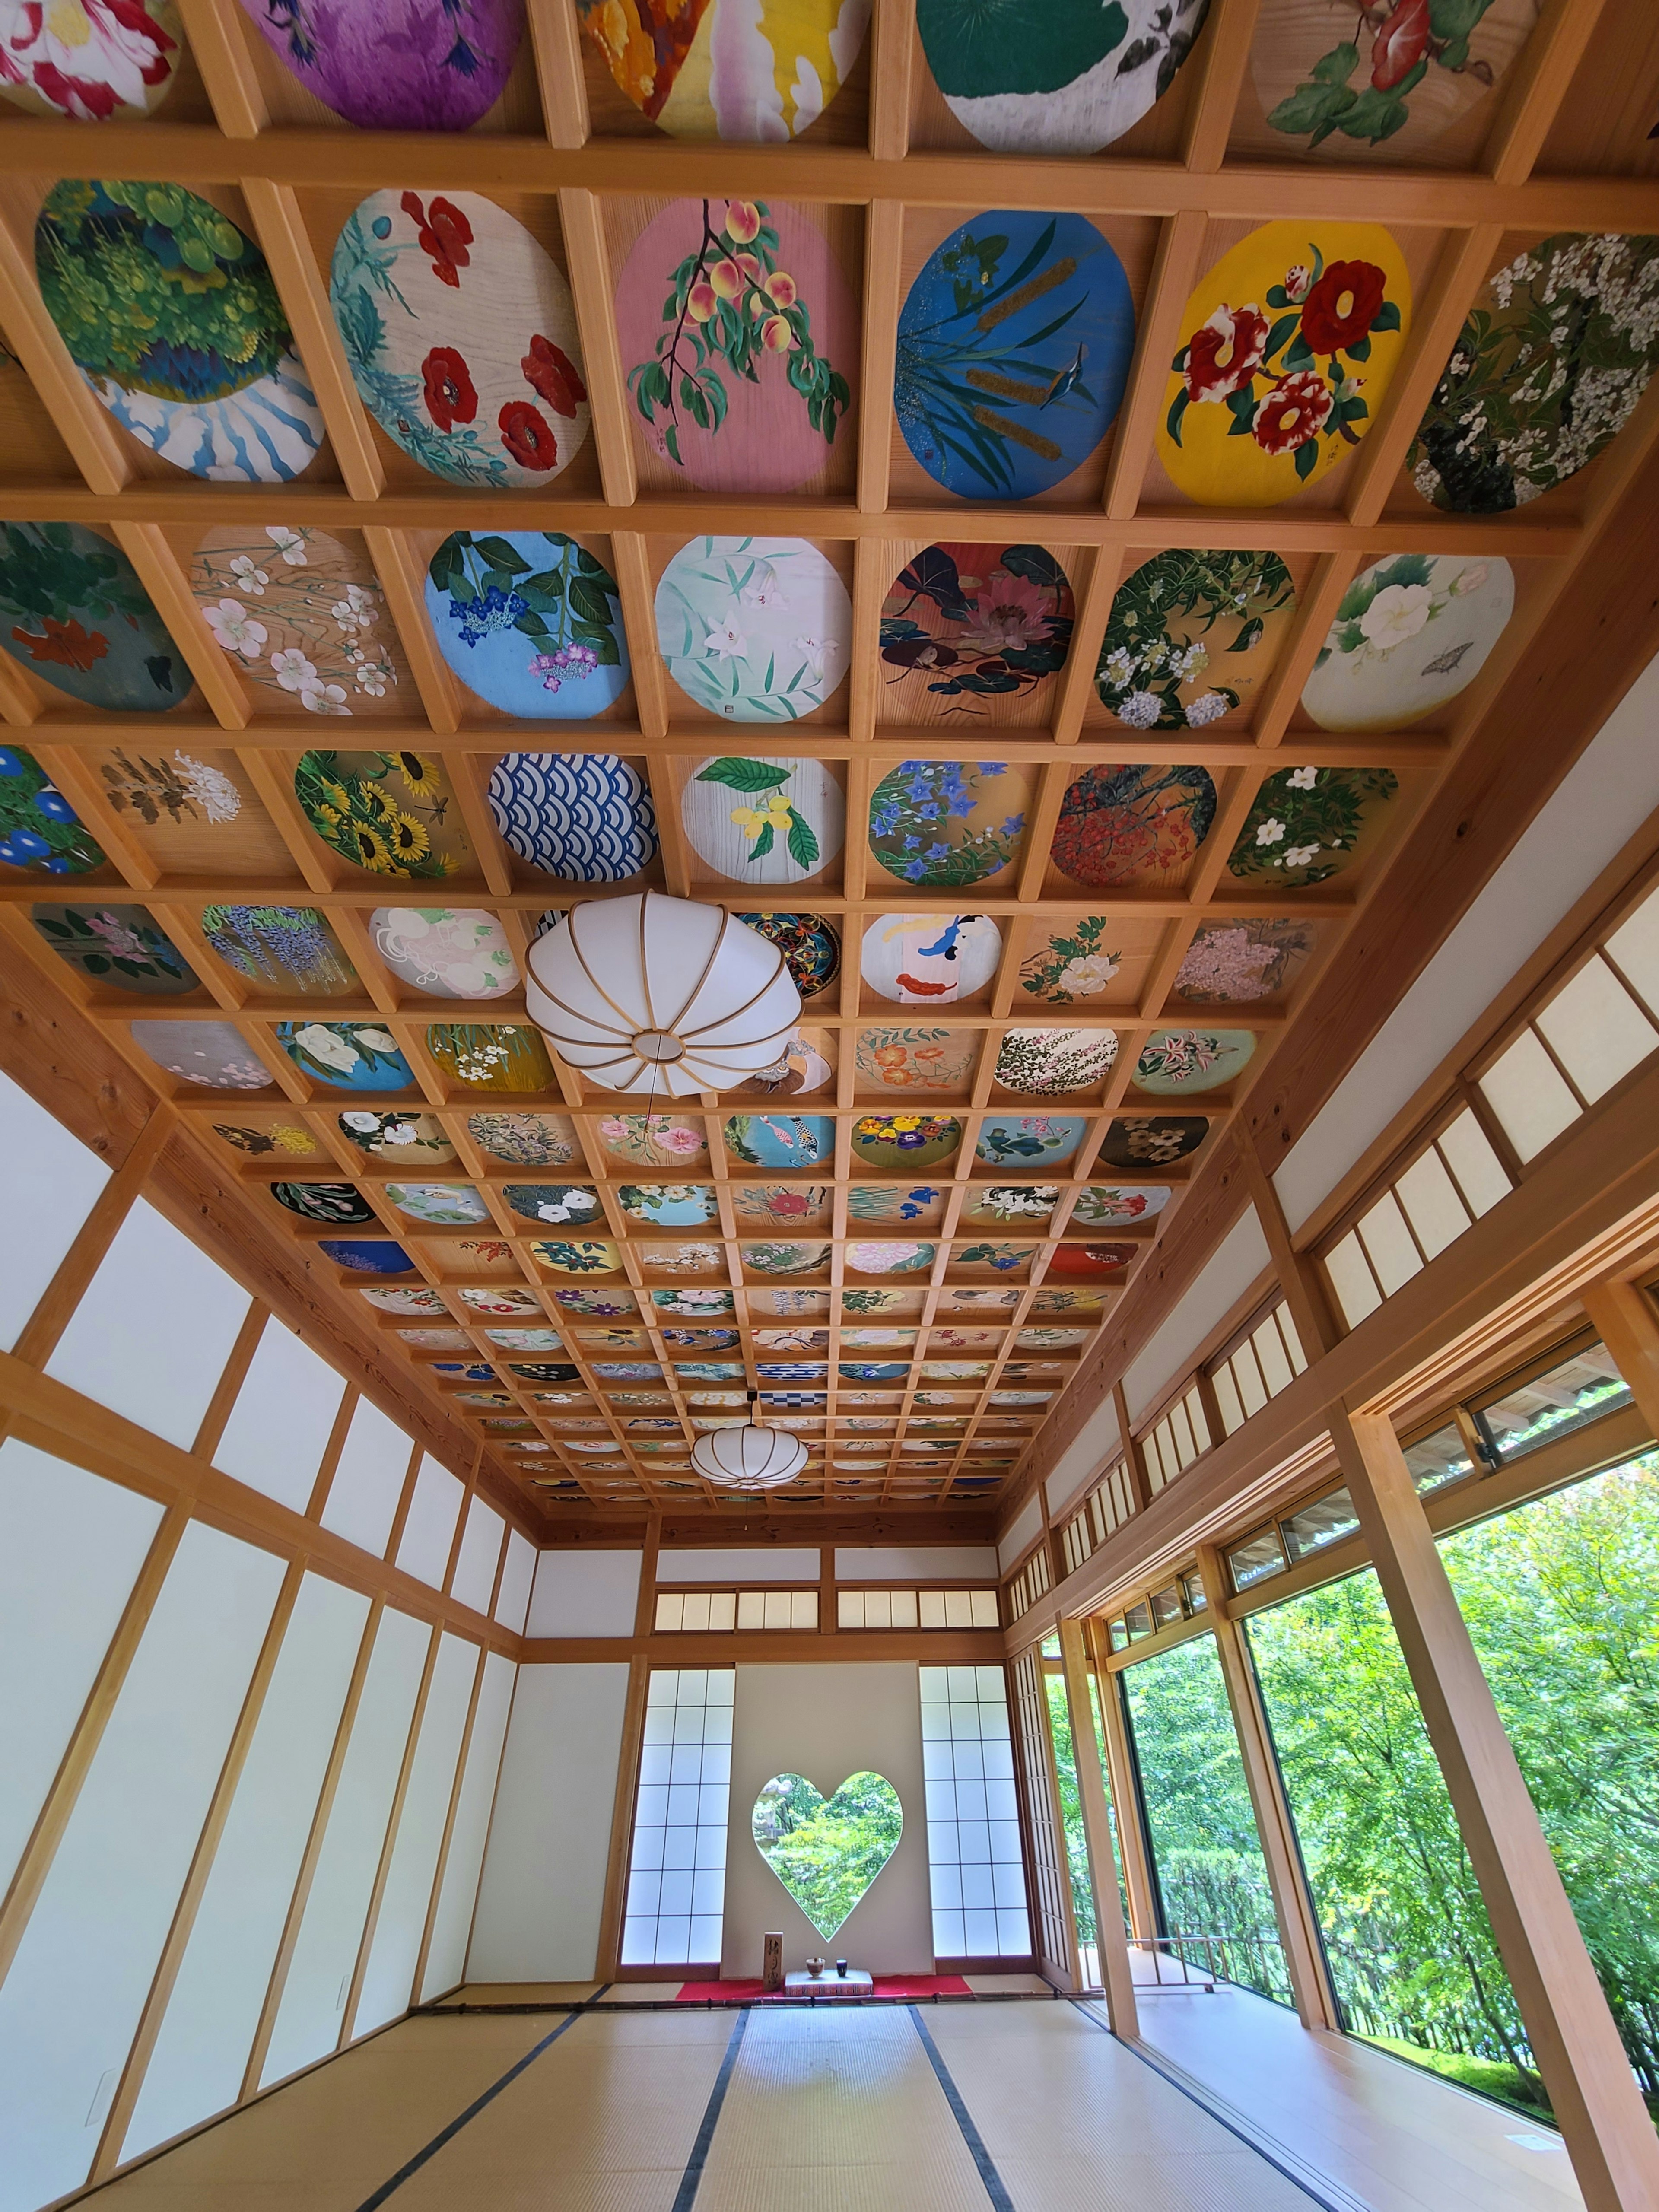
[1332,1407,1659,2212]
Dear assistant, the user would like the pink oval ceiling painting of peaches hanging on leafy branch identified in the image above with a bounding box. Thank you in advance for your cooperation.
[617,199,858,493]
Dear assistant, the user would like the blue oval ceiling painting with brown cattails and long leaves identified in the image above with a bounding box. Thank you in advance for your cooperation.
[893,208,1135,500]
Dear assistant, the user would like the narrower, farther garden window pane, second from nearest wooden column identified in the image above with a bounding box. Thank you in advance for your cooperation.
[1117,1635,1290,2002]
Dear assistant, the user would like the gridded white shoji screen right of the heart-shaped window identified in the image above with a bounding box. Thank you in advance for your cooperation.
[918,1665,1031,1958]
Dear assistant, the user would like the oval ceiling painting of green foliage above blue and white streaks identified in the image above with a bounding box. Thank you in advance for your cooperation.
[35,177,323,484]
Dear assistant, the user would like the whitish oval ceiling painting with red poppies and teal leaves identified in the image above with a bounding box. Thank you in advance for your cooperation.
[330,186,588,491]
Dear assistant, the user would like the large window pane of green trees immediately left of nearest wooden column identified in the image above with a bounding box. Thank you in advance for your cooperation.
[1246,1568,1542,2113]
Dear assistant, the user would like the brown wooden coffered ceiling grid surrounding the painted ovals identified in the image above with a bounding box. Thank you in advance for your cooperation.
[0,0,1659,1535]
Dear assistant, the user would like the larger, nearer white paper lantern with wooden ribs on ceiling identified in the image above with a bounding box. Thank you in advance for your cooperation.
[524,891,801,1097]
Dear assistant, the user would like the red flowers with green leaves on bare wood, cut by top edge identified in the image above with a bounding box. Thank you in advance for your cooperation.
[1250,0,1537,164]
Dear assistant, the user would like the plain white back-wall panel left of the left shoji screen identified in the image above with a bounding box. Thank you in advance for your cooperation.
[467,1663,639,1982]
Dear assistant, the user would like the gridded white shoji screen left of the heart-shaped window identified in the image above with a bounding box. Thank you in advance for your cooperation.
[622,1668,737,1967]
